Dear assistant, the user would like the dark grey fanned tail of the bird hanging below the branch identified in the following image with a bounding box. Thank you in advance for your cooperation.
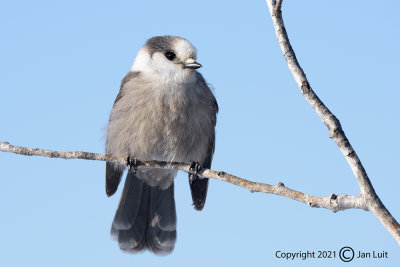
[111,172,176,255]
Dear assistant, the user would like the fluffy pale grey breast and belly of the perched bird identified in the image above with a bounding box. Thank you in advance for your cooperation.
[107,74,213,163]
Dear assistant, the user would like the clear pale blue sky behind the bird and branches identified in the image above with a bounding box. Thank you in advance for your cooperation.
[0,0,400,266]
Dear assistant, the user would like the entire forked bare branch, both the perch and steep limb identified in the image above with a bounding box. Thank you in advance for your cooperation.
[0,0,400,247]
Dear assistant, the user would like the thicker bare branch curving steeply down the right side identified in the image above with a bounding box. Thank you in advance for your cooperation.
[266,0,400,244]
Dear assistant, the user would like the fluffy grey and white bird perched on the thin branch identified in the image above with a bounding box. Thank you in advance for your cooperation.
[105,35,218,255]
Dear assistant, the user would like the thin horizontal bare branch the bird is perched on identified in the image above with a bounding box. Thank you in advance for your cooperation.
[0,142,368,212]
